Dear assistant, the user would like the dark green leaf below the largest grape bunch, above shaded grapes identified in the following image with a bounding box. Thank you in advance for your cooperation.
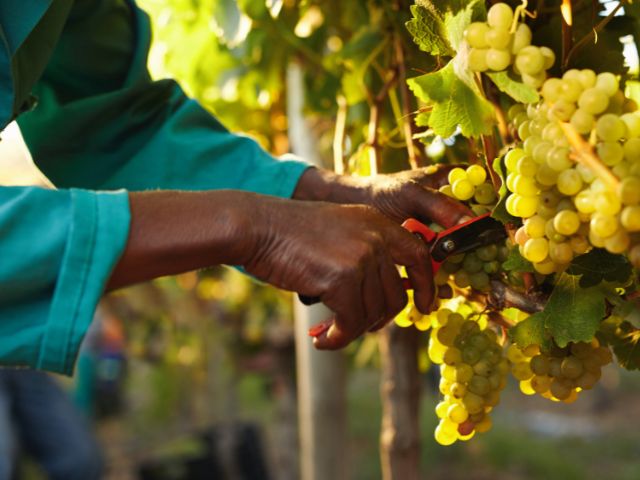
[540,273,606,347]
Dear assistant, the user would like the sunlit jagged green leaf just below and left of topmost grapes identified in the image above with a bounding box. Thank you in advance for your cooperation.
[407,62,494,138]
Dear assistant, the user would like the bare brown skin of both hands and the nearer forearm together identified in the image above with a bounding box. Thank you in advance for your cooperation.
[107,168,470,349]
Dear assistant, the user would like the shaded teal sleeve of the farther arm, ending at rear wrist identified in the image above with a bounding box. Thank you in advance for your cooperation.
[18,0,308,197]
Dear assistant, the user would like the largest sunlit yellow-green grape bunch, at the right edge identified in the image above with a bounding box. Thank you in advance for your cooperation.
[505,70,640,274]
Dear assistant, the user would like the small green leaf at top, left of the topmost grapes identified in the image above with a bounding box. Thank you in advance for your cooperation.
[406,2,455,56]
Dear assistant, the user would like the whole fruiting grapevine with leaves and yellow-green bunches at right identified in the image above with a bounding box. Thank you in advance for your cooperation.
[396,2,640,445]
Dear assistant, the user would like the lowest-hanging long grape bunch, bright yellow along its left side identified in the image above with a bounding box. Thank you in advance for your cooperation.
[429,308,509,445]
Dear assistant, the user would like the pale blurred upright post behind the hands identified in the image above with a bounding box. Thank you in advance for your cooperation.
[287,63,347,480]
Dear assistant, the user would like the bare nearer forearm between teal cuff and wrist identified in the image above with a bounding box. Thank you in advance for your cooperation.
[107,190,260,289]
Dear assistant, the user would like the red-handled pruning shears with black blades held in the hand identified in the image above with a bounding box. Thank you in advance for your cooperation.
[300,213,507,337]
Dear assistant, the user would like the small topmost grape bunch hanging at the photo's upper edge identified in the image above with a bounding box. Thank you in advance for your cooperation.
[464,3,555,89]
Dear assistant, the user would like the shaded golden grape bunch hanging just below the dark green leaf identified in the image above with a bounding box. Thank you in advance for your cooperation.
[507,338,613,403]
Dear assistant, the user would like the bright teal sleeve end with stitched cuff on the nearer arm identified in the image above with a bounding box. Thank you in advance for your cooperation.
[0,187,130,374]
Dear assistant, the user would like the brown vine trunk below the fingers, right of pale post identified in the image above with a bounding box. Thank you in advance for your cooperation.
[380,324,420,480]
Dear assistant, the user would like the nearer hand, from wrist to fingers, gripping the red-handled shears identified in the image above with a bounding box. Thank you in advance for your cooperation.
[241,198,434,349]
